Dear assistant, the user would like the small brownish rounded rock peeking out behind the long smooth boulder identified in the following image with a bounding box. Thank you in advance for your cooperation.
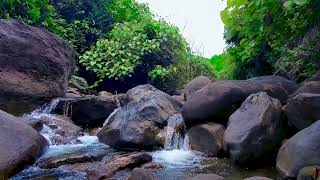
[183,76,213,99]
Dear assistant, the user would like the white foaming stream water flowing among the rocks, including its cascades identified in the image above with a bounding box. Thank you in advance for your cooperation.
[11,100,277,180]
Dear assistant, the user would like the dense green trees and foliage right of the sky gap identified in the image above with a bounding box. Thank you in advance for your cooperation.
[215,0,320,81]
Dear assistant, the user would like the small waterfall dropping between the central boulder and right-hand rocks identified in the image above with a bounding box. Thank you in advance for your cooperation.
[164,114,189,150]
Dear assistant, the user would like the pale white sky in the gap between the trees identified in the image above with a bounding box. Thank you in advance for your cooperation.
[137,0,226,57]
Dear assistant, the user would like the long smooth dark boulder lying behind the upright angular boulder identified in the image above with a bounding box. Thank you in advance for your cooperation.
[182,76,298,127]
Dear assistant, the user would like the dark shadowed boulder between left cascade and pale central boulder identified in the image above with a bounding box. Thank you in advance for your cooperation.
[52,96,118,128]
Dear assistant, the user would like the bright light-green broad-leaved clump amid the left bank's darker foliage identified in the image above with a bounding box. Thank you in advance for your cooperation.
[80,21,159,79]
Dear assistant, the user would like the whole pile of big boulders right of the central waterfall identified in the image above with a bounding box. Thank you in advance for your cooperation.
[182,73,320,179]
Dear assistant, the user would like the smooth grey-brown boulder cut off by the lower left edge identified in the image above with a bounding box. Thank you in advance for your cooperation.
[0,111,48,179]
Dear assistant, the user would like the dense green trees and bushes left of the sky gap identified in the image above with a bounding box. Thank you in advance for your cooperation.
[0,0,213,93]
